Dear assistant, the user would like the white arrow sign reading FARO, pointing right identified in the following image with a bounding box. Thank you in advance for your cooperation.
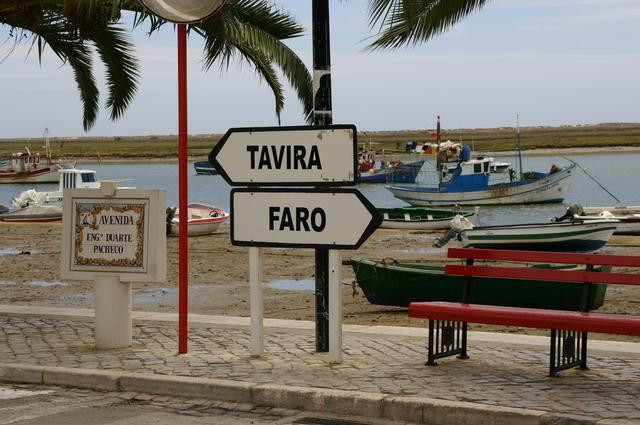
[231,188,382,249]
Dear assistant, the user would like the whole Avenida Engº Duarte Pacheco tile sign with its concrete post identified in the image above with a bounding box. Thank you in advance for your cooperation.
[60,182,167,349]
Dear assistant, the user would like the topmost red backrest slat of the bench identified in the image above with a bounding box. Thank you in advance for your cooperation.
[447,248,640,267]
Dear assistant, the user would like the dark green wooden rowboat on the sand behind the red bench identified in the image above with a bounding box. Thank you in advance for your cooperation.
[350,258,608,311]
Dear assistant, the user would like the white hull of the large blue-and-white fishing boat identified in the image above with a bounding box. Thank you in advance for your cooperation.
[387,165,575,207]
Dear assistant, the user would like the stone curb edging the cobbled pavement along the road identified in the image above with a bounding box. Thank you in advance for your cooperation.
[0,363,612,425]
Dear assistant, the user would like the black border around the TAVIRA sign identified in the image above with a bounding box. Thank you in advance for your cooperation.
[209,124,358,187]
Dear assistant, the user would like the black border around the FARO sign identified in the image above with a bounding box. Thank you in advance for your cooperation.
[231,188,382,249]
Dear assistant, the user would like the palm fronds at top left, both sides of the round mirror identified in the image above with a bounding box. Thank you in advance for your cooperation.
[0,0,313,130]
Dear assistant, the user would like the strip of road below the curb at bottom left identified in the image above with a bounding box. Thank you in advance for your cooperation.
[0,384,396,425]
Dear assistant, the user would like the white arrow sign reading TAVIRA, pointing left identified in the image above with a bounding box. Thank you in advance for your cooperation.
[209,124,358,186]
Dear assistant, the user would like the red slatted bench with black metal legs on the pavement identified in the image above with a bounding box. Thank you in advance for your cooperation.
[409,248,640,376]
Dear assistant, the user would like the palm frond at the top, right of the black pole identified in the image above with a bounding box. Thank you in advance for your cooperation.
[369,0,488,50]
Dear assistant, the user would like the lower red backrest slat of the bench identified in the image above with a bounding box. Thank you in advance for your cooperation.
[444,264,640,285]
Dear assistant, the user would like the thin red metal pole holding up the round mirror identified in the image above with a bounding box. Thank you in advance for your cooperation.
[178,24,189,354]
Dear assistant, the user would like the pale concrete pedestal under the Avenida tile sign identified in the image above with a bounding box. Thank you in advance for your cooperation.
[95,275,132,350]
